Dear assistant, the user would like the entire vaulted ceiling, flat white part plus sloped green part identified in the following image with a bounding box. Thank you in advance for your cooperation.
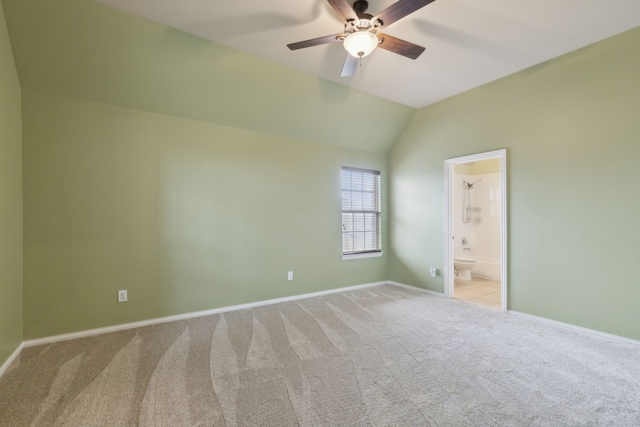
[1,0,640,152]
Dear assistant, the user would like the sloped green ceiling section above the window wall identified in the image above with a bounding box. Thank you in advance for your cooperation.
[2,0,416,153]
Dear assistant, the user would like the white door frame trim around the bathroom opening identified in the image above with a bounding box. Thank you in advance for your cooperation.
[443,149,507,313]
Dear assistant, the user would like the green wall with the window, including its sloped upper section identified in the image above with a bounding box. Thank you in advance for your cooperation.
[2,0,404,339]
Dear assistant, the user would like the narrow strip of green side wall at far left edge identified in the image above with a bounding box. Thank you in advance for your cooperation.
[0,0,22,366]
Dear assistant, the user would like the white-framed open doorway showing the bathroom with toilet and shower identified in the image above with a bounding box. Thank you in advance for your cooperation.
[443,149,507,313]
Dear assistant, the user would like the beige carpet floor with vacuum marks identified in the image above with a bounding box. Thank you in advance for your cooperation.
[0,285,640,426]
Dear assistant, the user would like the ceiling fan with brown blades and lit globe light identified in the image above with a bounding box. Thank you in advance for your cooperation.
[287,0,435,77]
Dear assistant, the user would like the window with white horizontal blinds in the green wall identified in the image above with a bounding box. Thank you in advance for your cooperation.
[341,167,382,258]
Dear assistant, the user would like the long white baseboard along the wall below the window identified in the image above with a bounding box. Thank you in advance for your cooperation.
[23,281,388,347]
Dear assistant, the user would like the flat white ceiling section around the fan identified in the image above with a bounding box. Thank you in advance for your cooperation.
[97,0,640,108]
